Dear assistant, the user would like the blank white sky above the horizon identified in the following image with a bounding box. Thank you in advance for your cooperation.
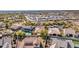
[0,0,79,10]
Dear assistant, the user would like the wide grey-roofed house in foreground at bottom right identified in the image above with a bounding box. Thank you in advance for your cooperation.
[50,38,74,48]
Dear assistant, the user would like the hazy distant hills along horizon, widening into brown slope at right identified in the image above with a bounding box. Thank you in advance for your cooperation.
[0,10,79,19]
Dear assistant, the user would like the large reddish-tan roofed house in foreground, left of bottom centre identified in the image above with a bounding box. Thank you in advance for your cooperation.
[17,36,40,48]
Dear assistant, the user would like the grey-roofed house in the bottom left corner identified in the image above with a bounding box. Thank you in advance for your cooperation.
[0,35,13,48]
